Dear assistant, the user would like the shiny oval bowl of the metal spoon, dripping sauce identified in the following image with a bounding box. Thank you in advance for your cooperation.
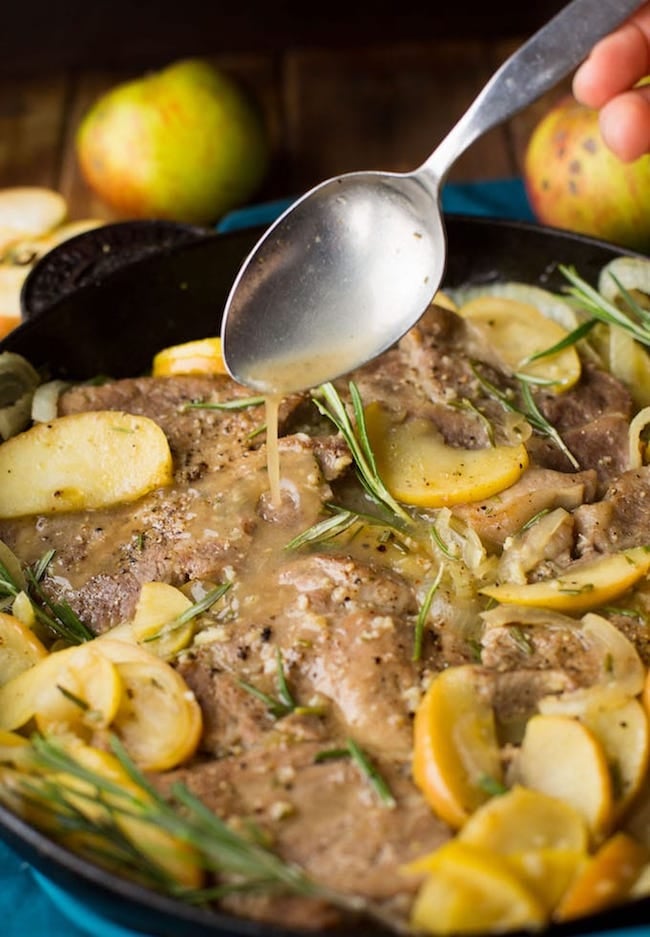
[224,172,445,393]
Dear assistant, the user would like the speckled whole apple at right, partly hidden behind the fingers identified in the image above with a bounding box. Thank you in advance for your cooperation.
[524,95,650,253]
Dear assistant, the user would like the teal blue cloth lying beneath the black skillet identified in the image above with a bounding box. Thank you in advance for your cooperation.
[0,179,650,937]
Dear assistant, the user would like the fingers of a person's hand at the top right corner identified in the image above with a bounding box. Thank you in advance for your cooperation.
[573,2,650,162]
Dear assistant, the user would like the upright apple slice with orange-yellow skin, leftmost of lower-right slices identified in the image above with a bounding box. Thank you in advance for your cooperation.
[413,665,502,829]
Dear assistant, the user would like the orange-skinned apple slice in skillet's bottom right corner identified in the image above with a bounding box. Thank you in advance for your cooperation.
[553,832,650,921]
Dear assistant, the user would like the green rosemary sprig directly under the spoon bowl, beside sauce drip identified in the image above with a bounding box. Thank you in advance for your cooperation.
[313,381,412,523]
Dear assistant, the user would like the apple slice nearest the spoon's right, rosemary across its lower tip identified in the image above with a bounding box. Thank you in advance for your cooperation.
[458,296,582,391]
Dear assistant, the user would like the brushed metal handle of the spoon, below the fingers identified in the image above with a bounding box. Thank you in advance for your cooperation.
[418,0,641,187]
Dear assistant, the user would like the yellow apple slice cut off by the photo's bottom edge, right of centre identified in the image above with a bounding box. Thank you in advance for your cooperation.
[410,840,547,935]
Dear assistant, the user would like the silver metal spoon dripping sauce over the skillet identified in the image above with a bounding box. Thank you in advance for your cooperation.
[222,0,641,394]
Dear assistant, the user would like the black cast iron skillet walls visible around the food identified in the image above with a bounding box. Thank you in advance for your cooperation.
[0,216,650,937]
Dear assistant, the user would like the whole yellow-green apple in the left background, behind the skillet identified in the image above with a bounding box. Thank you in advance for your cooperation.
[75,59,269,224]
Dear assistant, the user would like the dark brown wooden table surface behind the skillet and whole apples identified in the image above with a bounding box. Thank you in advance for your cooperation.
[0,17,569,226]
